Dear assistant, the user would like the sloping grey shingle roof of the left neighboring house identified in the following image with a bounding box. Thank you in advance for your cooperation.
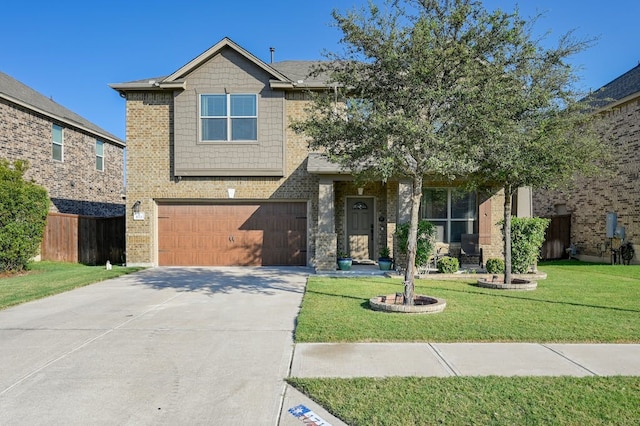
[0,72,125,146]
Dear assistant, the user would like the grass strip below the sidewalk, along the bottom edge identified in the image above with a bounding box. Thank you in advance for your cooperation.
[289,377,640,426]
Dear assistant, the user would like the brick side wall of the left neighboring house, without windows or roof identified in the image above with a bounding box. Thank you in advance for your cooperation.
[0,100,124,217]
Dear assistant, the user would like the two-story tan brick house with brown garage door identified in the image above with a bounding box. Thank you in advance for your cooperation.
[111,38,530,270]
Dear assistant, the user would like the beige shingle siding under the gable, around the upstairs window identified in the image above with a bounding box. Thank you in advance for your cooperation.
[175,49,285,176]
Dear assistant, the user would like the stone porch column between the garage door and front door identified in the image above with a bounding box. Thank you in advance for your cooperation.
[316,178,338,271]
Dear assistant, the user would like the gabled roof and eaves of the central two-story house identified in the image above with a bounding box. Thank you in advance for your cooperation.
[110,37,327,93]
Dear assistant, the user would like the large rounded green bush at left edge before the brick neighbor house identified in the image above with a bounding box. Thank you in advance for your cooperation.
[0,159,49,272]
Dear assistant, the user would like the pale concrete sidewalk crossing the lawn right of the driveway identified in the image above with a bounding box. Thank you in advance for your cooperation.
[291,343,640,377]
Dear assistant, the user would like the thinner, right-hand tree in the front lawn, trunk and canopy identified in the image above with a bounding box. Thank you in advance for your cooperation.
[460,10,610,283]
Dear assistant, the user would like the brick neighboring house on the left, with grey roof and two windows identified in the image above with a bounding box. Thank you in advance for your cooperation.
[0,72,125,217]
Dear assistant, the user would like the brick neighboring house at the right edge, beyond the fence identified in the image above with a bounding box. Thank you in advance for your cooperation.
[533,65,640,263]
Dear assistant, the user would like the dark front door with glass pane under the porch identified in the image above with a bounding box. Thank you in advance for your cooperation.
[347,198,374,260]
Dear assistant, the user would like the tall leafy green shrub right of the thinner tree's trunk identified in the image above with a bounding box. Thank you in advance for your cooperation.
[511,217,550,274]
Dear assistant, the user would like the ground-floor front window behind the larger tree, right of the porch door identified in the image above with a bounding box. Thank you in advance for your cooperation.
[421,188,478,243]
